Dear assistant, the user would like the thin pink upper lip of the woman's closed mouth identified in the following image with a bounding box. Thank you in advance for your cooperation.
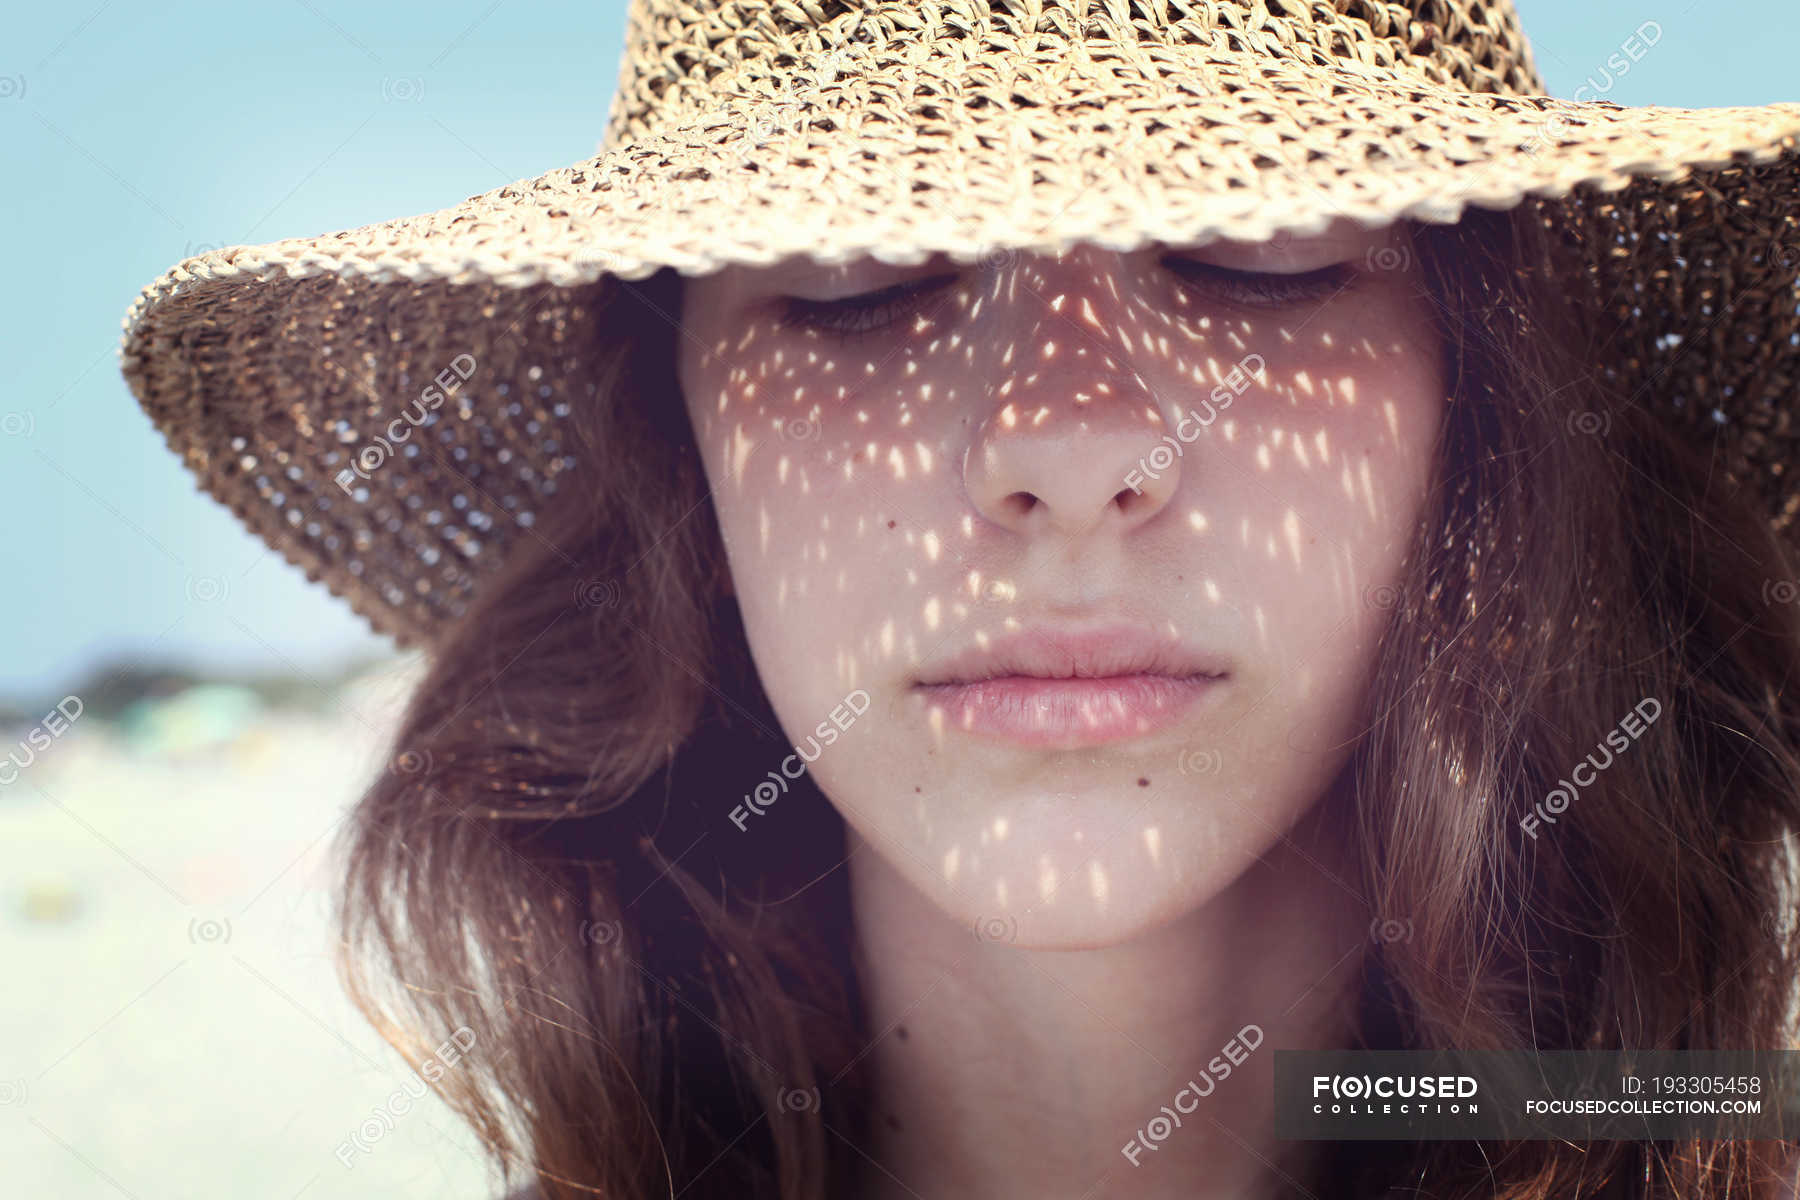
[918,624,1228,685]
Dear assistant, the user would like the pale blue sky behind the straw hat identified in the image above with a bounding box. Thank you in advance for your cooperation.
[0,0,1800,702]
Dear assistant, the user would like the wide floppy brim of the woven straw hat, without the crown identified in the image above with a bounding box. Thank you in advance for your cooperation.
[121,49,1800,644]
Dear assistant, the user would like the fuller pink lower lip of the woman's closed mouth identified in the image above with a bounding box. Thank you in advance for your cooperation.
[918,675,1226,748]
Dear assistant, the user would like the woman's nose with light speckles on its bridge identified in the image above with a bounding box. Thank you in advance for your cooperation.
[963,255,1181,538]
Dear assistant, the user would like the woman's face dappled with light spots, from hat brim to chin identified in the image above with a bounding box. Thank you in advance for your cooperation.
[679,223,1445,946]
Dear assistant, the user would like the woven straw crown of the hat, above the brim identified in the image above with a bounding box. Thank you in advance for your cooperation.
[605,0,1544,146]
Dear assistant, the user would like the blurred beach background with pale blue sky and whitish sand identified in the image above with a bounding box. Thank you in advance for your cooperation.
[0,0,1800,1200]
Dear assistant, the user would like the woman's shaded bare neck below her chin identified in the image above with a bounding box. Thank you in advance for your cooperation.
[851,808,1368,1200]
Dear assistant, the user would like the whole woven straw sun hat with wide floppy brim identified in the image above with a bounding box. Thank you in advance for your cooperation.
[122,0,1800,644]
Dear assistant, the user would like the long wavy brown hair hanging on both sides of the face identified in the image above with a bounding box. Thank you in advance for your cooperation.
[338,201,1800,1200]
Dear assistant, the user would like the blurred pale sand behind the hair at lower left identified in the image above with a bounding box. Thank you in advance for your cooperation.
[0,657,499,1200]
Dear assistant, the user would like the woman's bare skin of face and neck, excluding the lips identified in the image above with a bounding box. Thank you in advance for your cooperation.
[677,223,1445,1196]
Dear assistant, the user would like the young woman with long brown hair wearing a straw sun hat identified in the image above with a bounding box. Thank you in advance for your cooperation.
[116,0,1800,1200]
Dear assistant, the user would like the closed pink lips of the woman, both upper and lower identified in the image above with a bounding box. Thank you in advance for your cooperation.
[914,626,1229,748]
